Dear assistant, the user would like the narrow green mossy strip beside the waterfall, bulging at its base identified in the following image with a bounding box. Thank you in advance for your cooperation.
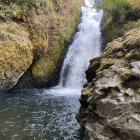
[32,12,80,83]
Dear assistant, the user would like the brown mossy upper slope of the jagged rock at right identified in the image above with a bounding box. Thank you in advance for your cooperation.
[86,28,140,82]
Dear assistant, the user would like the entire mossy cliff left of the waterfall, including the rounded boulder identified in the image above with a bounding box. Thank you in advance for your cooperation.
[0,0,82,92]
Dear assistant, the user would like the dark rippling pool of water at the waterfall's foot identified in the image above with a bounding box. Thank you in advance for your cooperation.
[0,89,81,140]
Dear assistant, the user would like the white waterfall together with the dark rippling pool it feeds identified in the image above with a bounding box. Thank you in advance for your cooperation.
[0,0,102,140]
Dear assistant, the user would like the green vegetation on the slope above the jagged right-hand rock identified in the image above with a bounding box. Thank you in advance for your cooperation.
[96,0,140,44]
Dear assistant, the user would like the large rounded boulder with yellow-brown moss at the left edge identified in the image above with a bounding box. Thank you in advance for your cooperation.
[0,22,33,92]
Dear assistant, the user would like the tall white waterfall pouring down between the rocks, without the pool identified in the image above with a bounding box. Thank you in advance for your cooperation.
[59,0,102,89]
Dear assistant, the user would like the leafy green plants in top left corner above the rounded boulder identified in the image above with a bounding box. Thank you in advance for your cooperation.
[0,0,53,21]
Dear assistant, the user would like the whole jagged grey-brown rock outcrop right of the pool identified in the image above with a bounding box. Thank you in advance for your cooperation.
[77,28,140,140]
